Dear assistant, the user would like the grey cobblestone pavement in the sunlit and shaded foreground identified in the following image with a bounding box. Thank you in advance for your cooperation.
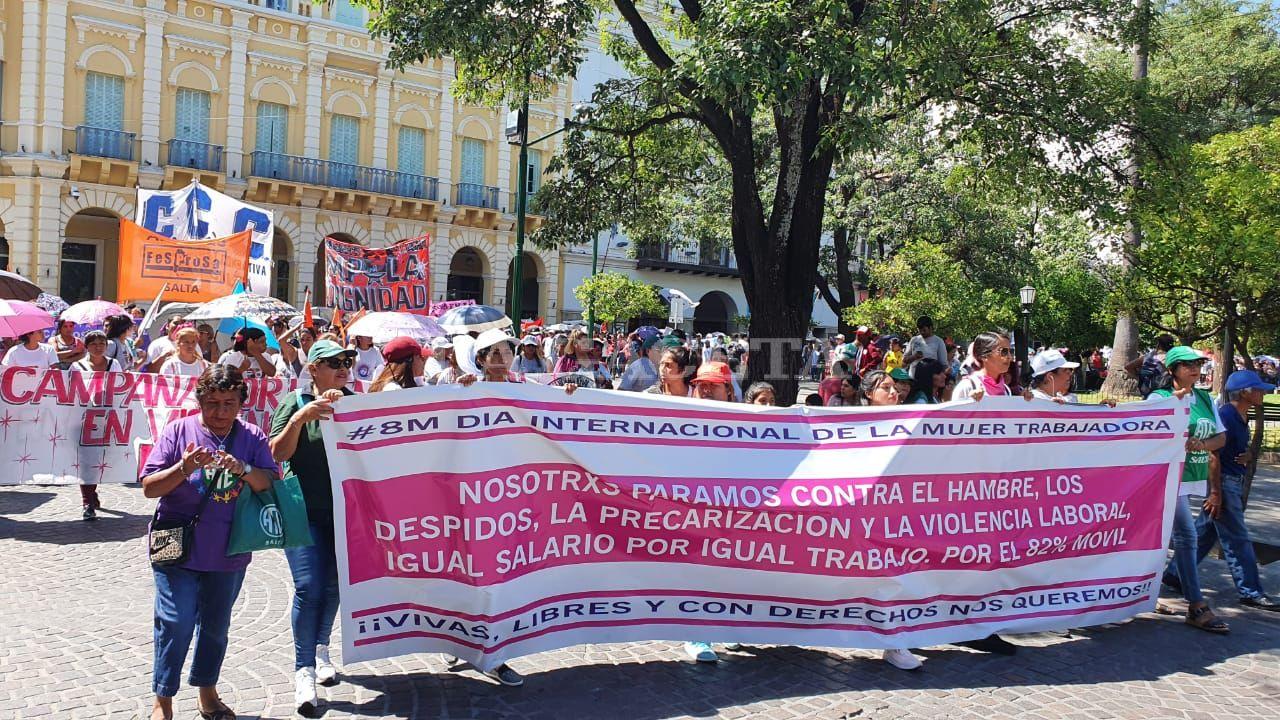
[0,468,1280,720]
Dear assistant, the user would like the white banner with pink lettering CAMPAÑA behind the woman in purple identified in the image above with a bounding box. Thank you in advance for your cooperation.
[0,366,294,486]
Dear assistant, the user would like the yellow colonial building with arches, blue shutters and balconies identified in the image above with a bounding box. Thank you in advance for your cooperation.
[0,0,572,320]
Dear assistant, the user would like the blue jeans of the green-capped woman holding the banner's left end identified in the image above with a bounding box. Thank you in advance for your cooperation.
[284,521,338,670]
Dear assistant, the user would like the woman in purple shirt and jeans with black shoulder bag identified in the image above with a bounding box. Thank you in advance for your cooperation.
[141,365,279,720]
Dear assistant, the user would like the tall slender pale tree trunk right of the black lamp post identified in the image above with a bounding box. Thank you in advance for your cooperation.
[1102,0,1151,397]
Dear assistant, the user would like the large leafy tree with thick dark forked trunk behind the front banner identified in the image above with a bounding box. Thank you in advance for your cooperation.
[365,0,1130,401]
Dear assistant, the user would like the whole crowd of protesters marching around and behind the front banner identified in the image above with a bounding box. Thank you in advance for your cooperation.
[4,303,1280,720]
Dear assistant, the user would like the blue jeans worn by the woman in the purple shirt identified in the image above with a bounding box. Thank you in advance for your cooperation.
[151,568,244,697]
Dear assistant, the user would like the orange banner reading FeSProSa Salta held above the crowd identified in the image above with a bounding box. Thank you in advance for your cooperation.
[118,219,253,302]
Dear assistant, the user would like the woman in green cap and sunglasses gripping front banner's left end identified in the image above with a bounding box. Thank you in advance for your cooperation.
[271,340,356,715]
